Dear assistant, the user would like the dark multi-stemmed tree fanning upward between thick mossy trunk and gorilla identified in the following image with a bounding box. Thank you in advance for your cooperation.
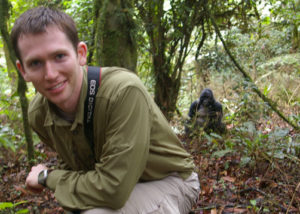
[136,0,205,120]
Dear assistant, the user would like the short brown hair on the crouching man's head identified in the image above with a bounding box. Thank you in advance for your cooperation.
[10,7,79,61]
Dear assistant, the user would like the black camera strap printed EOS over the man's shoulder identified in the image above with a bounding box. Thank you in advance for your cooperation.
[84,66,101,153]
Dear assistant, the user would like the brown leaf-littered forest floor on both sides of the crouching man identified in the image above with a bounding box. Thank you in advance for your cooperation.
[0,117,300,214]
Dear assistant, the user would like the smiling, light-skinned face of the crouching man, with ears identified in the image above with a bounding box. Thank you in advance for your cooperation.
[17,26,87,112]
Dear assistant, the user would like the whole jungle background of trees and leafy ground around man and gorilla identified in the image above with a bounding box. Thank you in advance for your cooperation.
[0,0,300,214]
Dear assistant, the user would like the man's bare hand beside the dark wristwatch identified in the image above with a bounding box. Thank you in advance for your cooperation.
[25,164,48,193]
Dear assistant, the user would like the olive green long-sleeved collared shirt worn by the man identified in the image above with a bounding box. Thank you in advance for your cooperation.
[29,67,194,210]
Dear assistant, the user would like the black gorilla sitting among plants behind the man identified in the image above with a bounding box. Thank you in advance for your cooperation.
[185,88,226,135]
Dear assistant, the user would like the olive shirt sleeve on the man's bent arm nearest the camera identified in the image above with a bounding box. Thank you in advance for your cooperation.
[47,86,151,210]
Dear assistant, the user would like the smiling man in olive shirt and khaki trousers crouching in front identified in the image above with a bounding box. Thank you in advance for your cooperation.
[11,7,199,214]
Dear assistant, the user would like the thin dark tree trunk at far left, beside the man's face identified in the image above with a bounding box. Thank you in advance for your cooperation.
[0,0,34,165]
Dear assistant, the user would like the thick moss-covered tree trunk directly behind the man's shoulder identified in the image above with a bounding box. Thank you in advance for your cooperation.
[94,0,137,72]
